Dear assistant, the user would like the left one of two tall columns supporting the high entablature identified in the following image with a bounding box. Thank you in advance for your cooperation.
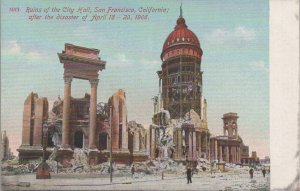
[62,76,73,148]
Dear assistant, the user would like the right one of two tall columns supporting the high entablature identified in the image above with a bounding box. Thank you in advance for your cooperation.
[89,79,99,149]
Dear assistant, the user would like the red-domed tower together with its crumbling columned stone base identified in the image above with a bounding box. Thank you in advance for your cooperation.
[150,10,210,161]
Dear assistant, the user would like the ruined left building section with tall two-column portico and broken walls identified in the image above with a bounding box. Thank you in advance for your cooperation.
[18,44,148,164]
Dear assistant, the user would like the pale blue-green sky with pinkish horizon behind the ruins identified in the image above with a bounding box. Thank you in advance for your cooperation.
[1,0,270,158]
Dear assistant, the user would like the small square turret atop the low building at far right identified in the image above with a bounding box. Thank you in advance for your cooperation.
[222,113,239,137]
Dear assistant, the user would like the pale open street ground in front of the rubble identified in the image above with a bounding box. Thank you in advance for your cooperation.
[1,169,270,191]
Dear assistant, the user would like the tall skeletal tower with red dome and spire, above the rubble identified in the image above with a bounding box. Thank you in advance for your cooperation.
[157,7,203,119]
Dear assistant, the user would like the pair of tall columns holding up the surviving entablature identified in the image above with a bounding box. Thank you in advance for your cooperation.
[62,76,99,149]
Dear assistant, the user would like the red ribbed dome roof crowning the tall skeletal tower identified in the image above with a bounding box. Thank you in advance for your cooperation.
[161,17,202,60]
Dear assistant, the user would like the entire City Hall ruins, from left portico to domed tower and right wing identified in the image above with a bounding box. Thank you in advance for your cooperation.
[18,12,259,165]
